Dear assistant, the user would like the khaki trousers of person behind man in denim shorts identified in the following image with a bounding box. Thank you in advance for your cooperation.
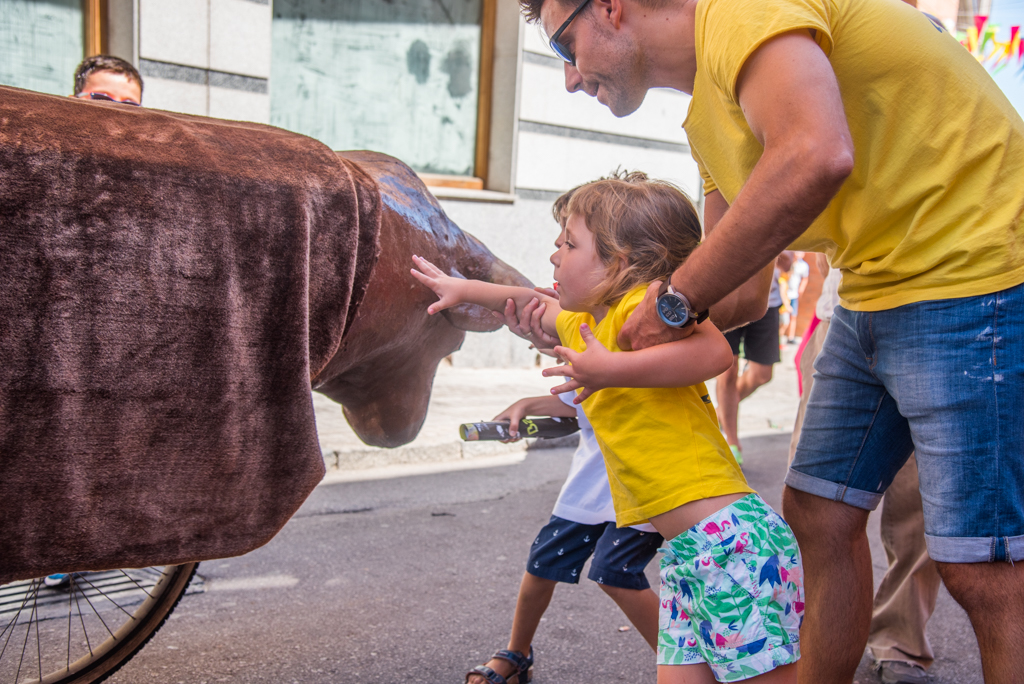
[790,320,942,668]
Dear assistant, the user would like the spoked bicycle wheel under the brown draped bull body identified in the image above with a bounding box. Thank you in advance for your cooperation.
[0,563,199,684]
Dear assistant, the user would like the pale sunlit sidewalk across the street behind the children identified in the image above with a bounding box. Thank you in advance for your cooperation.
[313,339,799,481]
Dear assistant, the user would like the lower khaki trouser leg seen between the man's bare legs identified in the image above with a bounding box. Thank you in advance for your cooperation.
[867,456,942,684]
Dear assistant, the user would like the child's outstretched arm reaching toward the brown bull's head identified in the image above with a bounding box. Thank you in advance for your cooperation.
[412,256,562,336]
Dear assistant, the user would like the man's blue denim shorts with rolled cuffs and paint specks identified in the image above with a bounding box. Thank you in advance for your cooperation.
[785,285,1024,563]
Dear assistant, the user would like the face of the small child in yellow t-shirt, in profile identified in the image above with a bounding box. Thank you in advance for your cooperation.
[551,214,607,311]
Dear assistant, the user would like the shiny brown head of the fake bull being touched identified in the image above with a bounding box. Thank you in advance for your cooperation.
[313,152,532,446]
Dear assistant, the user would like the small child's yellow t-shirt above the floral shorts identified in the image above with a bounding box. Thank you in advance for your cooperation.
[557,286,754,527]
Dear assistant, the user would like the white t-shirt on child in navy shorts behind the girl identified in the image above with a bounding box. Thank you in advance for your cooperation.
[552,392,657,532]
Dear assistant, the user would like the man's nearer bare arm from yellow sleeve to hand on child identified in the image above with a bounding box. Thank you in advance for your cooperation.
[620,31,853,349]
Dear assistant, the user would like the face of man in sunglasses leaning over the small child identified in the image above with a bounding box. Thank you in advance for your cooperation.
[541,0,647,117]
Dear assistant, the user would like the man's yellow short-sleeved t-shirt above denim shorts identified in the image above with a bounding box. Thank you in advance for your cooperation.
[683,0,1024,311]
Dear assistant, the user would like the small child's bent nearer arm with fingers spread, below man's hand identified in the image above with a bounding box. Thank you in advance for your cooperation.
[544,320,732,403]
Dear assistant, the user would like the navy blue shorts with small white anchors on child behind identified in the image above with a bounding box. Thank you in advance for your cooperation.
[526,515,665,590]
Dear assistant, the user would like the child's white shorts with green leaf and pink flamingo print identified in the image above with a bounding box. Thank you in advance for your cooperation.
[657,494,804,682]
